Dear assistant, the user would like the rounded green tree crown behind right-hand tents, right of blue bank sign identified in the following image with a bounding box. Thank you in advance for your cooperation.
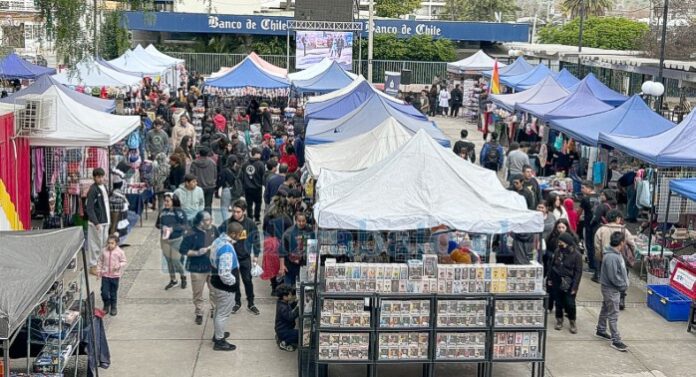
[539,17,649,50]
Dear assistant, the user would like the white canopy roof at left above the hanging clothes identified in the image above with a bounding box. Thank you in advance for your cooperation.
[0,86,140,147]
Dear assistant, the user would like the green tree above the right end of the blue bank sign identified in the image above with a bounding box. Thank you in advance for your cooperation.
[440,0,519,21]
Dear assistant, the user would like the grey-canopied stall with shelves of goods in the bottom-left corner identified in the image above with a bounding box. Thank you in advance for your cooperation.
[0,227,108,377]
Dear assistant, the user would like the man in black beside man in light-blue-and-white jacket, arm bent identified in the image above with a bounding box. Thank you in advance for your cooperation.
[219,200,261,315]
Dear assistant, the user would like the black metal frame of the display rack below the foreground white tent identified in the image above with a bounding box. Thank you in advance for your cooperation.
[298,284,548,377]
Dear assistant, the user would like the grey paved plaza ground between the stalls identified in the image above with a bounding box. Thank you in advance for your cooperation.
[93,118,696,377]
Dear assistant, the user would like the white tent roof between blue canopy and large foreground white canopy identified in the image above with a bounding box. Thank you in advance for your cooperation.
[305,117,412,177]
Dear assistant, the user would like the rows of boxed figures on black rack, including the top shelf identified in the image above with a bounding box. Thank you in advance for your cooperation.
[300,255,546,376]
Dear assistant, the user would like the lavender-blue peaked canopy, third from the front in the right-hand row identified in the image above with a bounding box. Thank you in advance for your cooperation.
[515,82,614,121]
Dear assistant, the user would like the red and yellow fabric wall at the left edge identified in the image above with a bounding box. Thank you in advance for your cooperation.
[0,113,31,230]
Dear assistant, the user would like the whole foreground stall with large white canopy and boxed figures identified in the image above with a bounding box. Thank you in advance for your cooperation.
[299,131,546,376]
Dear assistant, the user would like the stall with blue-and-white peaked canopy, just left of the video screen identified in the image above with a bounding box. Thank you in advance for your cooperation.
[205,53,290,146]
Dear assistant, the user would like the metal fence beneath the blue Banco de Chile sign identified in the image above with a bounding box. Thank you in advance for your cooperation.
[167,52,447,84]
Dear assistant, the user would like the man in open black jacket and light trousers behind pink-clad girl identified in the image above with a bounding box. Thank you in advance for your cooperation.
[85,168,111,275]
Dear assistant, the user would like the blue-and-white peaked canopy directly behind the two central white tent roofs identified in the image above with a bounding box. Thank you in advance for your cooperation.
[305,96,450,147]
